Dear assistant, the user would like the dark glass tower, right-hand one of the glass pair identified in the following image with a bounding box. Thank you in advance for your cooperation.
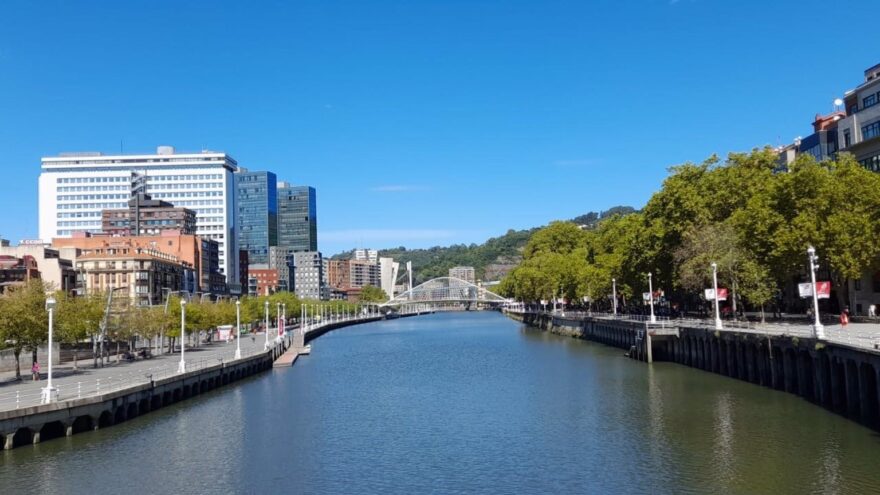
[278,182,318,253]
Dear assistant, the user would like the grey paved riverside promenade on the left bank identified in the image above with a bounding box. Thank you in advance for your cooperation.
[0,329,277,411]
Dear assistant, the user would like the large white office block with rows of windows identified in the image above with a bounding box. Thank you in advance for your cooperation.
[39,146,240,292]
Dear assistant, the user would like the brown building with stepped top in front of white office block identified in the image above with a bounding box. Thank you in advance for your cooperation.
[101,193,196,236]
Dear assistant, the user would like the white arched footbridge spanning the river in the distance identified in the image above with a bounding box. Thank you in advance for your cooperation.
[380,277,509,311]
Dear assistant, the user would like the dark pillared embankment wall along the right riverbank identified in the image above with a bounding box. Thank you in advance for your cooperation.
[507,313,880,430]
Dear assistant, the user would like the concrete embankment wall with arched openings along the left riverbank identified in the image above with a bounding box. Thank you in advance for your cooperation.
[0,317,398,450]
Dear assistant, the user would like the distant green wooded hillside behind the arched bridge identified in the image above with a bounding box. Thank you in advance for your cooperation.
[333,206,635,284]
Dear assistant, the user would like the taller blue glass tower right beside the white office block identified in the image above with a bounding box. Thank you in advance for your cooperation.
[235,171,278,265]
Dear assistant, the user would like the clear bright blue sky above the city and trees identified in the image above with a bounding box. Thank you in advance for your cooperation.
[0,0,880,254]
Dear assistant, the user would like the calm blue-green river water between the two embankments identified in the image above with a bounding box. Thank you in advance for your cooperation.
[0,313,880,495]
